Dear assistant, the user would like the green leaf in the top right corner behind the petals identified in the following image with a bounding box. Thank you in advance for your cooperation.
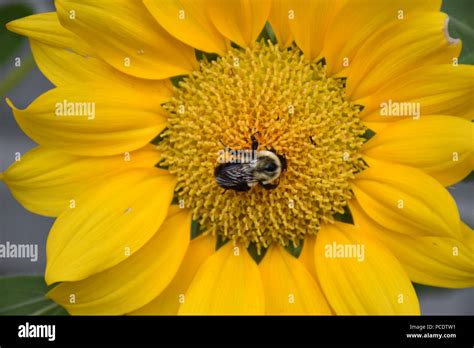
[441,0,474,64]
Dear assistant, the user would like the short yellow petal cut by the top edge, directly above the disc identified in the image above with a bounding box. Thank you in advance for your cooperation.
[208,0,270,47]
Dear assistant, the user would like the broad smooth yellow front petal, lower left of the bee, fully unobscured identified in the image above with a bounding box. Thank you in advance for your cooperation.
[46,168,176,284]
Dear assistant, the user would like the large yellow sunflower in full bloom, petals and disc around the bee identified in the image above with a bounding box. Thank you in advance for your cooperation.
[1,0,474,315]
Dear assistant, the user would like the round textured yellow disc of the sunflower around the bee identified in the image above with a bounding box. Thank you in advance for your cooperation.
[159,43,366,251]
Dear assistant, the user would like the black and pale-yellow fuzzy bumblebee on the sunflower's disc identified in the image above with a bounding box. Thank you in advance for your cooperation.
[214,135,287,192]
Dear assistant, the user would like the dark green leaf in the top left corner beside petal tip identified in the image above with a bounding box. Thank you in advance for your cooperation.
[0,4,33,64]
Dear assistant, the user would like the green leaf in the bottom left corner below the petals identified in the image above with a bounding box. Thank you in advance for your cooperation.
[0,276,67,315]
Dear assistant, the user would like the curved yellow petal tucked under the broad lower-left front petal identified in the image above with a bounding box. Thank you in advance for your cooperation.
[48,207,191,315]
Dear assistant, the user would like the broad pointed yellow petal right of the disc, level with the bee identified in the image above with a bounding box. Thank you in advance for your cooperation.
[352,157,460,237]
